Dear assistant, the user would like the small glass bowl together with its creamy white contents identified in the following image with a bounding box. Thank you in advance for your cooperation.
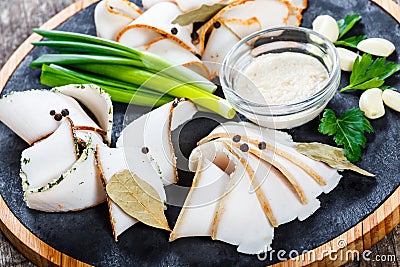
[220,27,341,129]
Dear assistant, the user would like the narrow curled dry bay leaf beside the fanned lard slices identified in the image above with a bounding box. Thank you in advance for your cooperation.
[295,143,375,177]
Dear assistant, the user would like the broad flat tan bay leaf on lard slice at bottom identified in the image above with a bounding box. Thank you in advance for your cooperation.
[106,170,171,231]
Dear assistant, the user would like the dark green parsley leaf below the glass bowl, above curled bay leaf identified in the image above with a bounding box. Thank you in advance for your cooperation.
[318,108,374,162]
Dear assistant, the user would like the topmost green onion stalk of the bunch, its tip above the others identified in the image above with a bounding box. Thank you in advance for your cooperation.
[33,29,217,93]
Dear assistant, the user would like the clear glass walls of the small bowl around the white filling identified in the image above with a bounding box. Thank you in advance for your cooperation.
[220,27,341,129]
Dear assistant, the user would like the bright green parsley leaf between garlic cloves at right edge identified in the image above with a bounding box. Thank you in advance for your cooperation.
[340,54,400,92]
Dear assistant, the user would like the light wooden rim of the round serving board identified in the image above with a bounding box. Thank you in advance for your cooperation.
[0,0,400,266]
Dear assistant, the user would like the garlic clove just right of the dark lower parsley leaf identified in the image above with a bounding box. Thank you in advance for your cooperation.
[359,88,385,119]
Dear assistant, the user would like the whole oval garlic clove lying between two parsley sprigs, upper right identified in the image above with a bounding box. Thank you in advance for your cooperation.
[357,38,396,57]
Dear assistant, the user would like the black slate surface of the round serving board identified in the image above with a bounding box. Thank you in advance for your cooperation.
[0,0,400,266]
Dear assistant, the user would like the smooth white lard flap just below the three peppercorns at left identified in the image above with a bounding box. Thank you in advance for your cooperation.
[20,118,77,191]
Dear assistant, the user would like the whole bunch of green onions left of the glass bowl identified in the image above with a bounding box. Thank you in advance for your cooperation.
[31,30,235,118]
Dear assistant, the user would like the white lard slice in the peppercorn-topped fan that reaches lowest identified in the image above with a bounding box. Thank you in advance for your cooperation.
[212,153,274,254]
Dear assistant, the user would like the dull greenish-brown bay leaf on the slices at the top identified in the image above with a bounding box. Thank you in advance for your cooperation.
[172,3,227,26]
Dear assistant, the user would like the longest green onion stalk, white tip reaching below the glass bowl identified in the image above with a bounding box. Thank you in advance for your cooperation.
[31,54,234,117]
